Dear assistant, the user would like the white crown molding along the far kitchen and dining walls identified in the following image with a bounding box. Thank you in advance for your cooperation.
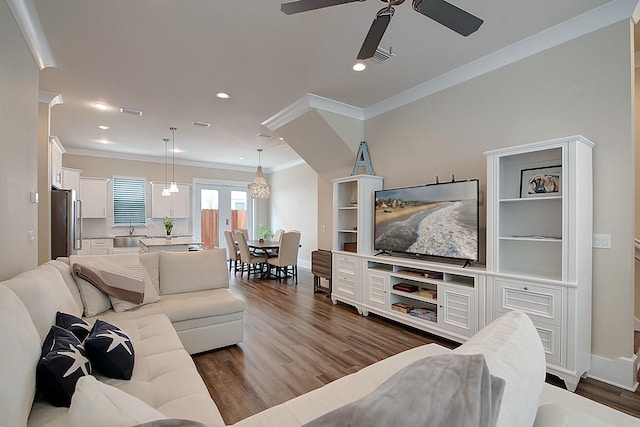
[62,147,304,173]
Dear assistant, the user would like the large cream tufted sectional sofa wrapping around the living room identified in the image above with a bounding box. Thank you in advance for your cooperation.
[0,251,640,427]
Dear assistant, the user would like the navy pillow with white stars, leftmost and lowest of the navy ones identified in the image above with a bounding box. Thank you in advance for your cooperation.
[36,325,91,406]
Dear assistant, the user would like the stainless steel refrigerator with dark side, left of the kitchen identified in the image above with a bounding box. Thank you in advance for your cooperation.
[51,189,82,259]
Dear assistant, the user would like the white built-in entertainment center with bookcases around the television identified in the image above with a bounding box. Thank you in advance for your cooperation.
[331,136,593,391]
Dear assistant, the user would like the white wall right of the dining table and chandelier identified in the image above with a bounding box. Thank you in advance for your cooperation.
[268,164,318,268]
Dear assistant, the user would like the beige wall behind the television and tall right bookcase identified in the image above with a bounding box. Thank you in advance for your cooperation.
[365,22,635,359]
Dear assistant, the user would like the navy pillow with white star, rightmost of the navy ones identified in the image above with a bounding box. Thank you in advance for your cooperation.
[84,320,135,380]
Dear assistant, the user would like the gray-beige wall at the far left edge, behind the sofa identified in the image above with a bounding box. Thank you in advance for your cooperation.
[0,1,38,280]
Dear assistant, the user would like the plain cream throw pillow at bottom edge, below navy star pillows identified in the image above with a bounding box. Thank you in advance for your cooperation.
[64,375,166,427]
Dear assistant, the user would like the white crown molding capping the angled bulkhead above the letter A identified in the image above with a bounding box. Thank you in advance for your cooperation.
[261,93,364,131]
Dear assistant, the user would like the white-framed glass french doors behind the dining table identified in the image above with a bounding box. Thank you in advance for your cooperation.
[193,183,253,249]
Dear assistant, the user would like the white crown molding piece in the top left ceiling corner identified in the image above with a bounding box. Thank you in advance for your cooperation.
[7,0,57,70]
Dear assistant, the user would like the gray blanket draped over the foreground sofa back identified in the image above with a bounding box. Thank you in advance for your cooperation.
[305,354,505,427]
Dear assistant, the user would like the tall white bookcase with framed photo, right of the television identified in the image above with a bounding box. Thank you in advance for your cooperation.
[485,136,594,391]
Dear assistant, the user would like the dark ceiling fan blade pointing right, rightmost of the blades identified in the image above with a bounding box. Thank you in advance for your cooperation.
[413,0,484,37]
